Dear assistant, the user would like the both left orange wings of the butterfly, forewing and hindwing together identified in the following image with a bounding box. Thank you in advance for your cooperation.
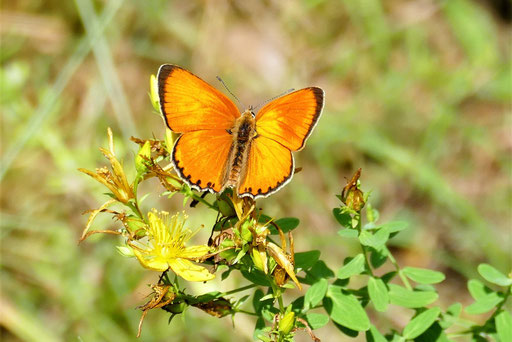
[158,64,240,192]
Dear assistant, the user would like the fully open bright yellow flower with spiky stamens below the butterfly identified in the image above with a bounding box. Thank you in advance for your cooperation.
[129,209,215,281]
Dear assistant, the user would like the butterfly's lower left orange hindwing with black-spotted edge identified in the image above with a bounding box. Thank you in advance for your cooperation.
[172,130,233,192]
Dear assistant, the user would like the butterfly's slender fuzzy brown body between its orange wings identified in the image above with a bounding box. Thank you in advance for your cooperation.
[226,111,256,187]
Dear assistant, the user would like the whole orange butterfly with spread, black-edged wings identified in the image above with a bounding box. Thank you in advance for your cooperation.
[157,64,324,199]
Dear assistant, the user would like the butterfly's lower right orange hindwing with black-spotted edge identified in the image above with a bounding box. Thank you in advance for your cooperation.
[238,136,294,198]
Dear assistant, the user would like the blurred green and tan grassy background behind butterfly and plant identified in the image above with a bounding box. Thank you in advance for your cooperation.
[0,0,512,341]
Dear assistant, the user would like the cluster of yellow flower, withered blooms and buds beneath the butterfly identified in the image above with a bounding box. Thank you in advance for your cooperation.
[79,129,307,336]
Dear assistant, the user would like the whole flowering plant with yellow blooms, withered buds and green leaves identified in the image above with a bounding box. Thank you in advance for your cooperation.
[80,76,512,341]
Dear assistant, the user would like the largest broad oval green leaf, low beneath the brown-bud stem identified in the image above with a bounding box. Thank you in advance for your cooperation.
[327,285,370,331]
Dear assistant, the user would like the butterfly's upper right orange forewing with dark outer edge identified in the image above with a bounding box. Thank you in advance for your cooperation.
[256,87,324,151]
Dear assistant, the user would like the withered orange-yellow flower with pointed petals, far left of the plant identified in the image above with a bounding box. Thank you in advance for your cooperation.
[78,127,135,204]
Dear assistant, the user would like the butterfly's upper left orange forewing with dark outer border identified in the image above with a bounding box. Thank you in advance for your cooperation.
[158,64,240,133]
